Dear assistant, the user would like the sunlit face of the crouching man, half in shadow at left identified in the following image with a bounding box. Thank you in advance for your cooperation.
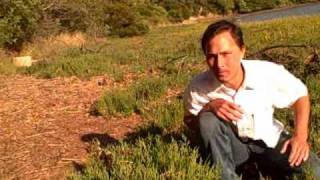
[206,31,245,85]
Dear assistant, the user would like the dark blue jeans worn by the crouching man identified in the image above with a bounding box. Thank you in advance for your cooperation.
[199,112,320,180]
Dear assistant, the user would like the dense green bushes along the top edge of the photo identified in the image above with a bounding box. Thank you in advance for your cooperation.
[0,0,315,52]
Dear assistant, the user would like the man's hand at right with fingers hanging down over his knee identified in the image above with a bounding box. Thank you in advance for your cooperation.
[281,136,310,167]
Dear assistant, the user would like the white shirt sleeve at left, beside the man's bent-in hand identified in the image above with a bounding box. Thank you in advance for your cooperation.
[183,85,209,116]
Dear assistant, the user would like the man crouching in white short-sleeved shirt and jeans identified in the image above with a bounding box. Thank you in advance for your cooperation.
[184,20,320,180]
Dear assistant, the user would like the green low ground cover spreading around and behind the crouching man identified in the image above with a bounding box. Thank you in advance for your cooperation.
[0,16,320,179]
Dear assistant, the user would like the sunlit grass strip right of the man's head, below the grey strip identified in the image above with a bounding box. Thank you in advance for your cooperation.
[243,16,320,52]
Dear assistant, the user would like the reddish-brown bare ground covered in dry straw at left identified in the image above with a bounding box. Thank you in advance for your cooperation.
[0,75,141,179]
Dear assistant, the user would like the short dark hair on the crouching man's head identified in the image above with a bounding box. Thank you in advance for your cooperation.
[201,20,244,54]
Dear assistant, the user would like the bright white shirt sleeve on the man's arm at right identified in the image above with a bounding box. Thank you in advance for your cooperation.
[269,64,308,108]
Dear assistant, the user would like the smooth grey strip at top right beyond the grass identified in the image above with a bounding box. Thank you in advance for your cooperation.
[236,2,320,22]
